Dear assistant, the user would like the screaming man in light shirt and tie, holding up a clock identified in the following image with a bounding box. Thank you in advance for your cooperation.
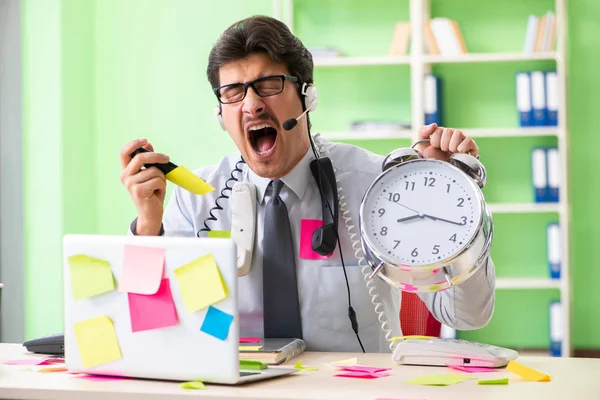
[120,17,494,352]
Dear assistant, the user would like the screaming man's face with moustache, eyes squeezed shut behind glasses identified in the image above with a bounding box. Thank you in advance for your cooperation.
[219,53,309,179]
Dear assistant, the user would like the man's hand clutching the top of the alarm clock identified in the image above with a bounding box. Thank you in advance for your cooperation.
[416,123,479,161]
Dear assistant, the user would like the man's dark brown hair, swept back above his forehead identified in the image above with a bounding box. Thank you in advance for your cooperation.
[206,16,313,88]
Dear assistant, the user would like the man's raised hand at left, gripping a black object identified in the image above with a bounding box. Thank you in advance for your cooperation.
[120,139,169,236]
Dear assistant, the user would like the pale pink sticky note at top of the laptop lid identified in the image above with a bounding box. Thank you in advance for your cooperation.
[119,245,165,294]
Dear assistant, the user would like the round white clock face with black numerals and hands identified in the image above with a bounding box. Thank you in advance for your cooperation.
[362,160,482,265]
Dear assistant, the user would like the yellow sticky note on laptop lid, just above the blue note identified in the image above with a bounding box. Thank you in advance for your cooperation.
[174,254,229,312]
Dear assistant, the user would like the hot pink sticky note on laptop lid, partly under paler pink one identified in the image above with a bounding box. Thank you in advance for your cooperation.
[127,279,178,332]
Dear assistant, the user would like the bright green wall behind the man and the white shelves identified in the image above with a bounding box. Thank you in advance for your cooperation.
[23,0,600,347]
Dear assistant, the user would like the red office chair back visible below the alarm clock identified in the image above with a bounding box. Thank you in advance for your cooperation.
[400,291,442,337]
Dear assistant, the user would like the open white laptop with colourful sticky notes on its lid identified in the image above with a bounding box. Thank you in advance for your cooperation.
[63,235,297,384]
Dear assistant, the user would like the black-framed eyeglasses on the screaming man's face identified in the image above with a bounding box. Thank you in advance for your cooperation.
[213,75,298,104]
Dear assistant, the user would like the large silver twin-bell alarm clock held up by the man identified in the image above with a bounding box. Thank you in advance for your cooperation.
[359,139,493,292]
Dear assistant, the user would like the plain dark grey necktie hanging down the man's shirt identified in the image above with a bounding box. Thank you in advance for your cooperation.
[263,180,302,338]
